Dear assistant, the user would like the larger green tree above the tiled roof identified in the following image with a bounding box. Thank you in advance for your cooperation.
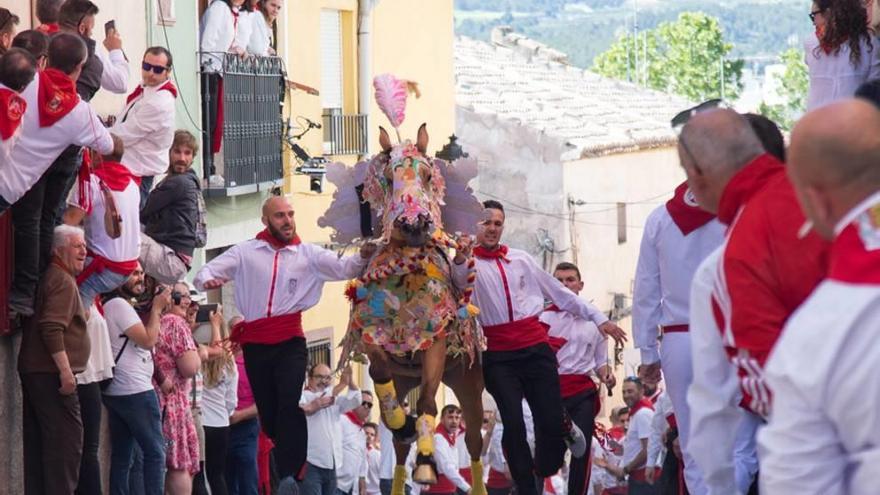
[594,12,743,101]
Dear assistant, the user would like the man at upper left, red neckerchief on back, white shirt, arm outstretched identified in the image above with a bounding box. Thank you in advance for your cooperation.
[0,33,121,316]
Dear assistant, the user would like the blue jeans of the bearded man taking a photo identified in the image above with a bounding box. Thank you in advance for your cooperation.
[104,390,165,495]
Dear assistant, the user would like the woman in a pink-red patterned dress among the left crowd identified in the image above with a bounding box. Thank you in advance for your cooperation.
[155,283,201,495]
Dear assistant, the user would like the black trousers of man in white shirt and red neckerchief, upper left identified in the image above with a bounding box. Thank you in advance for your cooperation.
[9,146,82,311]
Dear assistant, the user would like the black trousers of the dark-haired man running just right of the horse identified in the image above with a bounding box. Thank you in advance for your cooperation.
[483,344,566,495]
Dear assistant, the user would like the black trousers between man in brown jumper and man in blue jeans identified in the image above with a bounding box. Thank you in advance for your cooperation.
[75,382,104,495]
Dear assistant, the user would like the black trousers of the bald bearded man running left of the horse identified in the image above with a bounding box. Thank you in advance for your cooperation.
[242,337,309,480]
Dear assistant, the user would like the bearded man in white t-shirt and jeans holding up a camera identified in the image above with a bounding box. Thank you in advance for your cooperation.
[101,265,171,494]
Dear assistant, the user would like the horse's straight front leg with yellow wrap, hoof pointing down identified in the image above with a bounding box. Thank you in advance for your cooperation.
[413,337,446,484]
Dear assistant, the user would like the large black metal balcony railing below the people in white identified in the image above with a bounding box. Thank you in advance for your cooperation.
[202,54,284,195]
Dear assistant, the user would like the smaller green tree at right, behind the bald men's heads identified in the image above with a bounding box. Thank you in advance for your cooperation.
[758,48,810,130]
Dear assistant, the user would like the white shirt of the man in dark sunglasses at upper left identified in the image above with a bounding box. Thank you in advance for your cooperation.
[111,83,175,177]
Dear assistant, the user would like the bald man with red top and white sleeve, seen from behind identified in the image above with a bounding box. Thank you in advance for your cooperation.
[678,110,828,494]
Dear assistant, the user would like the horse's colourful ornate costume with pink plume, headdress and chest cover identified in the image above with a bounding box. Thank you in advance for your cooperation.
[318,74,483,364]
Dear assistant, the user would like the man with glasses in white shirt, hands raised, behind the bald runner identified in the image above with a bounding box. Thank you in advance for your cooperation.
[300,364,365,495]
